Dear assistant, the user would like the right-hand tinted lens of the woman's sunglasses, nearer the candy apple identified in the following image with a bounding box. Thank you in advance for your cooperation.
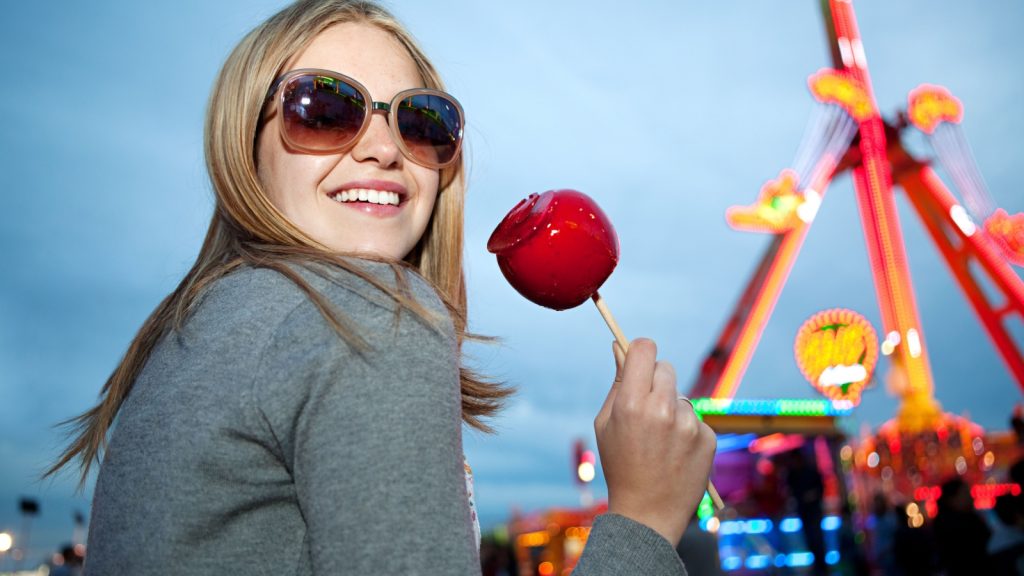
[397,94,462,166]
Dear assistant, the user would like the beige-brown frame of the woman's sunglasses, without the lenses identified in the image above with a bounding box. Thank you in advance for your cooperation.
[264,68,466,170]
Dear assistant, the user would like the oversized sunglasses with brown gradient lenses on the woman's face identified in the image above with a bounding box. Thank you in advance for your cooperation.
[266,69,464,168]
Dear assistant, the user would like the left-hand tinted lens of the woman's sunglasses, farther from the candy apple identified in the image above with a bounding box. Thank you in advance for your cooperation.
[283,75,367,151]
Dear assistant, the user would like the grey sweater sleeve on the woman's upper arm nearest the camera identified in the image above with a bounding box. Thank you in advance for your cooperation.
[254,293,480,574]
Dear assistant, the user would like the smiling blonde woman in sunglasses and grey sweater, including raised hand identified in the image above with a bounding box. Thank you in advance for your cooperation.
[51,0,714,575]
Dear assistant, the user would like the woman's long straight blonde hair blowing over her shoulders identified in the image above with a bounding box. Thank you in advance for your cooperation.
[45,0,513,487]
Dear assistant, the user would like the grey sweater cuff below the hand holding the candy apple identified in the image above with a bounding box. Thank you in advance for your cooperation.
[572,513,686,576]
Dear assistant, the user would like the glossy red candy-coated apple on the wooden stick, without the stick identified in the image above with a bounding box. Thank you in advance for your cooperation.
[487,190,618,310]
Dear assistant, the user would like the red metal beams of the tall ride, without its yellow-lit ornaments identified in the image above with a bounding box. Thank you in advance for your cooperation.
[690,0,1024,431]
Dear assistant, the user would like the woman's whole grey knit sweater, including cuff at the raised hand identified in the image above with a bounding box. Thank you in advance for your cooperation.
[85,262,685,576]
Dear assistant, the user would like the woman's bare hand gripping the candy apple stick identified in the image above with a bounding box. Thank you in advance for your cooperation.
[594,338,716,545]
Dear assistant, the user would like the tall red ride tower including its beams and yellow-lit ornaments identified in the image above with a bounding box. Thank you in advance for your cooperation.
[689,0,1024,434]
